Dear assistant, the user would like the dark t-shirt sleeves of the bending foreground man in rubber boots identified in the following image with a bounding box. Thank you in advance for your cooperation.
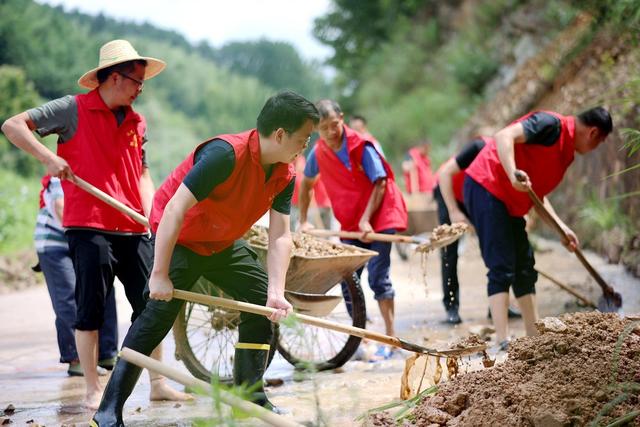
[183,139,295,215]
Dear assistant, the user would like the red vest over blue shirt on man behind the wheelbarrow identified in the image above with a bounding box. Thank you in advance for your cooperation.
[316,126,407,231]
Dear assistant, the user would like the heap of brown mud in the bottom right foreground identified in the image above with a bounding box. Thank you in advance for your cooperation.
[368,313,640,427]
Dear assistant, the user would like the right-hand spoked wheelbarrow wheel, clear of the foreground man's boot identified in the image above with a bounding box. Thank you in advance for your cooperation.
[278,273,367,371]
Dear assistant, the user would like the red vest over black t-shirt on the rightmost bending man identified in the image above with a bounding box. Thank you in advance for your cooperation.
[466,111,576,216]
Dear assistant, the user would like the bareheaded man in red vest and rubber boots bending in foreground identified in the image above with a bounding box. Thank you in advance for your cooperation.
[93,92,318,426]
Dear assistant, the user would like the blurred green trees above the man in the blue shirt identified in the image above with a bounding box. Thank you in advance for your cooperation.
[315,0,576,165]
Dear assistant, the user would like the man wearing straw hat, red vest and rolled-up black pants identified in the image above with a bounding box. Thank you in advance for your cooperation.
[2,40,190,409]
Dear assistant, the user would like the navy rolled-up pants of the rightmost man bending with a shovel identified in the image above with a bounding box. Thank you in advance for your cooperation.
[464,176,538,298]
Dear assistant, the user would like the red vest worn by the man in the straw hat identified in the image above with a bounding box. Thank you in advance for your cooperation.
[58,89,146,233]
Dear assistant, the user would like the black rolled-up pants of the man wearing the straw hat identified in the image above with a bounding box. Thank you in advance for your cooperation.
[66,230,153,331]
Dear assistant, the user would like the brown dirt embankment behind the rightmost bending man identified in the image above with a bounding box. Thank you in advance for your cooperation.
[455,10,640,276]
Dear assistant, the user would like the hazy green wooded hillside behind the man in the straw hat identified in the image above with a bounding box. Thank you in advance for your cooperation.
[0,0,330,252]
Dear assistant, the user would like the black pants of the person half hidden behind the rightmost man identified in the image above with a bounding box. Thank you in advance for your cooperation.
[433,186,468,311]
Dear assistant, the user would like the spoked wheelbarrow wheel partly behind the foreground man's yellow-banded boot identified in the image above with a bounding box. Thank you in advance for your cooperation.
[173,278,278,384]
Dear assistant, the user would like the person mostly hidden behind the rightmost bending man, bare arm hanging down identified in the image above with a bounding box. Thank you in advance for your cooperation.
[433,137,488,325]
